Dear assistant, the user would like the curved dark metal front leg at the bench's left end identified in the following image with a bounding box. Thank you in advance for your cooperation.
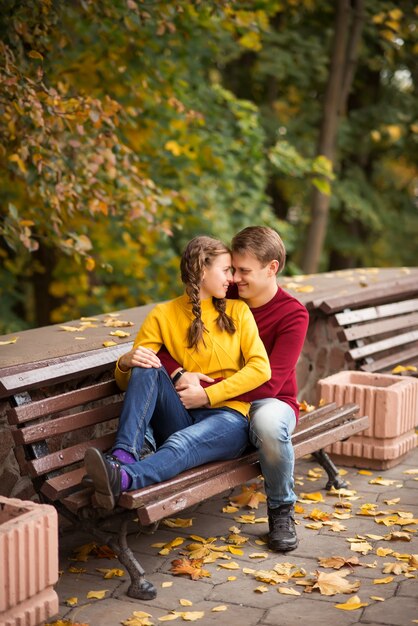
[109,520,157,600]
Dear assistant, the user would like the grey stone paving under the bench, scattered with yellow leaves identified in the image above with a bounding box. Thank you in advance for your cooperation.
[51,448,418,626]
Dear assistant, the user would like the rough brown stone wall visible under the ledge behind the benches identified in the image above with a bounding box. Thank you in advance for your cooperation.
[0,312,348,499]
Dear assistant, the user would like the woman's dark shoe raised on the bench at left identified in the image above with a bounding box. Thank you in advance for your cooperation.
[83,448,122,510]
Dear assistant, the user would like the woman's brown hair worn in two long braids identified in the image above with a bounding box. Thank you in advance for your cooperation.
[180,235,236,348]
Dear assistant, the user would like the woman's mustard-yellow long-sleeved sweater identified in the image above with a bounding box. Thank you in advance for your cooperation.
[115,294,271,415]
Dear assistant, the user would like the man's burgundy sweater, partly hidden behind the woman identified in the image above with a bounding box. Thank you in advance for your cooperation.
[158,287,309,418]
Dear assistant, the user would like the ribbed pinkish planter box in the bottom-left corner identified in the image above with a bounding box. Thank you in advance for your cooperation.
[0,496,58,626]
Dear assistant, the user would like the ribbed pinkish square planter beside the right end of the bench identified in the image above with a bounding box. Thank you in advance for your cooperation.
[318,371,418,469]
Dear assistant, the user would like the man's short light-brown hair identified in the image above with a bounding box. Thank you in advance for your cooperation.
[231,226,286,273]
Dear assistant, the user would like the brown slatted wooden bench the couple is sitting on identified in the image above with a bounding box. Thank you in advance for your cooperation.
[0,352,368,600]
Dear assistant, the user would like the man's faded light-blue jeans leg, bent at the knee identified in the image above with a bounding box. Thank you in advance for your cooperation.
[250,398,296,509]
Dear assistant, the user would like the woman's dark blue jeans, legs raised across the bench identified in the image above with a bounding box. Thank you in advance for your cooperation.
[113,367,249,489]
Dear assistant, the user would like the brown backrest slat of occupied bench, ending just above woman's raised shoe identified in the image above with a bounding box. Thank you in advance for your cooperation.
[27,433,115,477]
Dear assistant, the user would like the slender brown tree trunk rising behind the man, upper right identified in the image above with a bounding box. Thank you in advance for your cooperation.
[302,0,364,274]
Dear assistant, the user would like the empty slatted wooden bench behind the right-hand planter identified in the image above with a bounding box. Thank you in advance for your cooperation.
[309,277,418,376]
